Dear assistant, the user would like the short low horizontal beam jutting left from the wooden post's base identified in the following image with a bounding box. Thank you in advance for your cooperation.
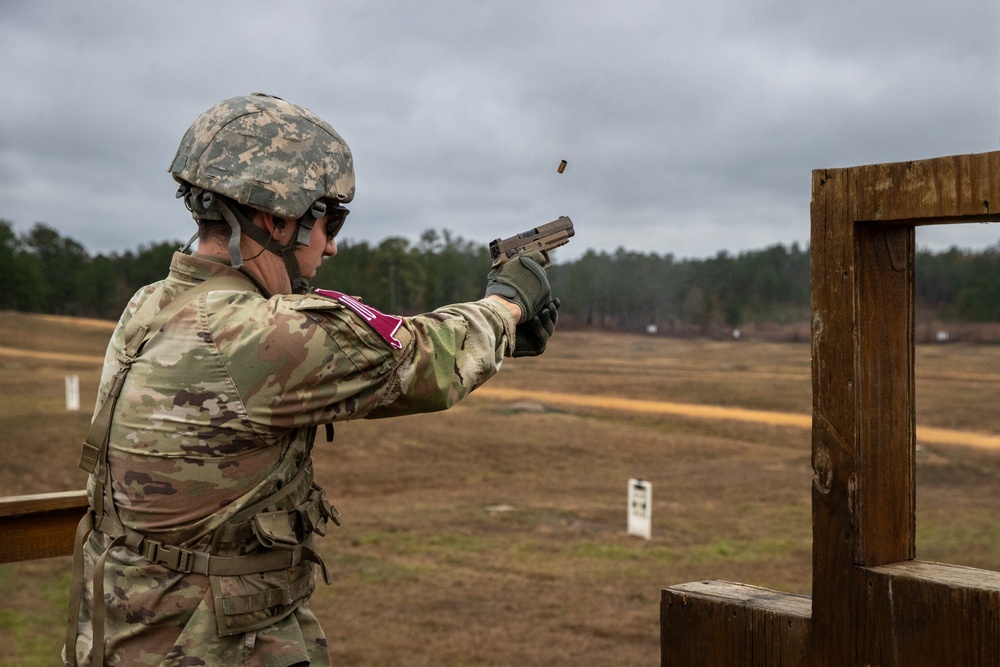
[660,581,812,667]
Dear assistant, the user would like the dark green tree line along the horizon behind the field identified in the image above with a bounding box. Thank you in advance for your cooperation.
[0,220,1000,335]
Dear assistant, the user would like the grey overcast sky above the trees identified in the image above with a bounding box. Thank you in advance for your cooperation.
[0,0,1000,259]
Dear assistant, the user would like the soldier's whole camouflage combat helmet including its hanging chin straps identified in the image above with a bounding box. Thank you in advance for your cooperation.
[170,93,354,292]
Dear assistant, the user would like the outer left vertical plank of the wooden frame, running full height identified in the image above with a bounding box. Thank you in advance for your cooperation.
[810,163,858,667]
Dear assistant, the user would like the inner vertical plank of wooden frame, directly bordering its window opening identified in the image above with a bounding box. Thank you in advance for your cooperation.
[852,225,916,565]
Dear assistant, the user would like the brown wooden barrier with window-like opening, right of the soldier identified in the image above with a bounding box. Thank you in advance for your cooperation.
[660,152,1000,667]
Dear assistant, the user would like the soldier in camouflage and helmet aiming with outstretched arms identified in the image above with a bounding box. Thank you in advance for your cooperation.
[64,94,558,667]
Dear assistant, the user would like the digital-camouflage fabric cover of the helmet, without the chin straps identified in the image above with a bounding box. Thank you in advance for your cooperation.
[170,93,354,219]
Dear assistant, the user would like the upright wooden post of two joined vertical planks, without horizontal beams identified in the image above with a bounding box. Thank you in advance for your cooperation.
[811,169,915,666]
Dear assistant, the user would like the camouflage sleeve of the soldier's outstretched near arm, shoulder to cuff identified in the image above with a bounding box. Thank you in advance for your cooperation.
[217,295,515,429]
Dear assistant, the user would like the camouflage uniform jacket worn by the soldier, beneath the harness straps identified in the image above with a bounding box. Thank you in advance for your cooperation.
[70,253,515,667]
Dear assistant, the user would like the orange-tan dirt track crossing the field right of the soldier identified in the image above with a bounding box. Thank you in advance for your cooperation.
[473,385,1000,449]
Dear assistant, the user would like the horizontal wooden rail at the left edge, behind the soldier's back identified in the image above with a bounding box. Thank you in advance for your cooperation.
[0,491,88,563]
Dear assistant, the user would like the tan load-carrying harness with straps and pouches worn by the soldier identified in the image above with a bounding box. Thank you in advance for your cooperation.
[65,273,340,667]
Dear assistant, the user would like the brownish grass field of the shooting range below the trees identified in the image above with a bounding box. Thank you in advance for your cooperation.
[0,313,1000,667]
